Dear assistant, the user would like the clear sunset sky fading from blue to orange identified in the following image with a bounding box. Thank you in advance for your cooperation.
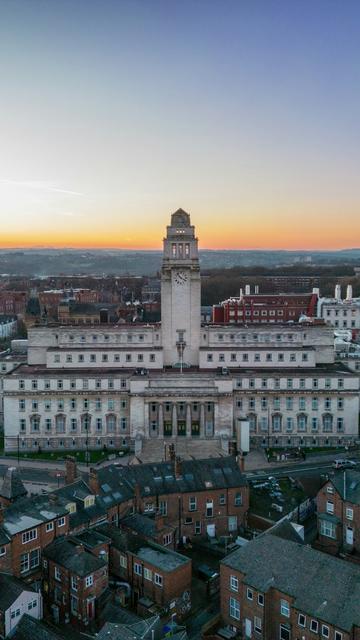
[0,0,360,249]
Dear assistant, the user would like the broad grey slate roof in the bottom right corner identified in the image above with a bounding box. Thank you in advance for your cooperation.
[221,533,360,632]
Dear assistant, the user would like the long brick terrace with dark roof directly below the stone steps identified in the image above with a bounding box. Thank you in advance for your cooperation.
[89,456,249,541]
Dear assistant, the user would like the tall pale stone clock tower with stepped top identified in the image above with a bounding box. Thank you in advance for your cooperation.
[161,209,201,368]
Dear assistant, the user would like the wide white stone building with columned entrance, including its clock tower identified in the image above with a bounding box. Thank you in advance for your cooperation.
[3,209,359,457]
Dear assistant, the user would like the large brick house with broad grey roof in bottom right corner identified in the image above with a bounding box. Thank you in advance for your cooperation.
[220,533,360,640]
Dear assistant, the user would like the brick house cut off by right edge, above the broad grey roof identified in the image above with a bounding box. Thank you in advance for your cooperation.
[317,470,360,554]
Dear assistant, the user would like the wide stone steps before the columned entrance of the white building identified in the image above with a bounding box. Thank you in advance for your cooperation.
[138,438,225,462]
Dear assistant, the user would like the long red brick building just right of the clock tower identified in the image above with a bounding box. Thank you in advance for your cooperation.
[212,293,318,324]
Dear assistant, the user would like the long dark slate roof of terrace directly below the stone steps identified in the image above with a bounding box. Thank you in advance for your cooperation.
[97,456,247,507]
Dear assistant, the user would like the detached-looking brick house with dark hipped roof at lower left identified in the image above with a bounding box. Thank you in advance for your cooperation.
[43,536,108,627]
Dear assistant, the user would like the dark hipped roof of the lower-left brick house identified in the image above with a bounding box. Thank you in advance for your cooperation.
[43,537,107,578]
